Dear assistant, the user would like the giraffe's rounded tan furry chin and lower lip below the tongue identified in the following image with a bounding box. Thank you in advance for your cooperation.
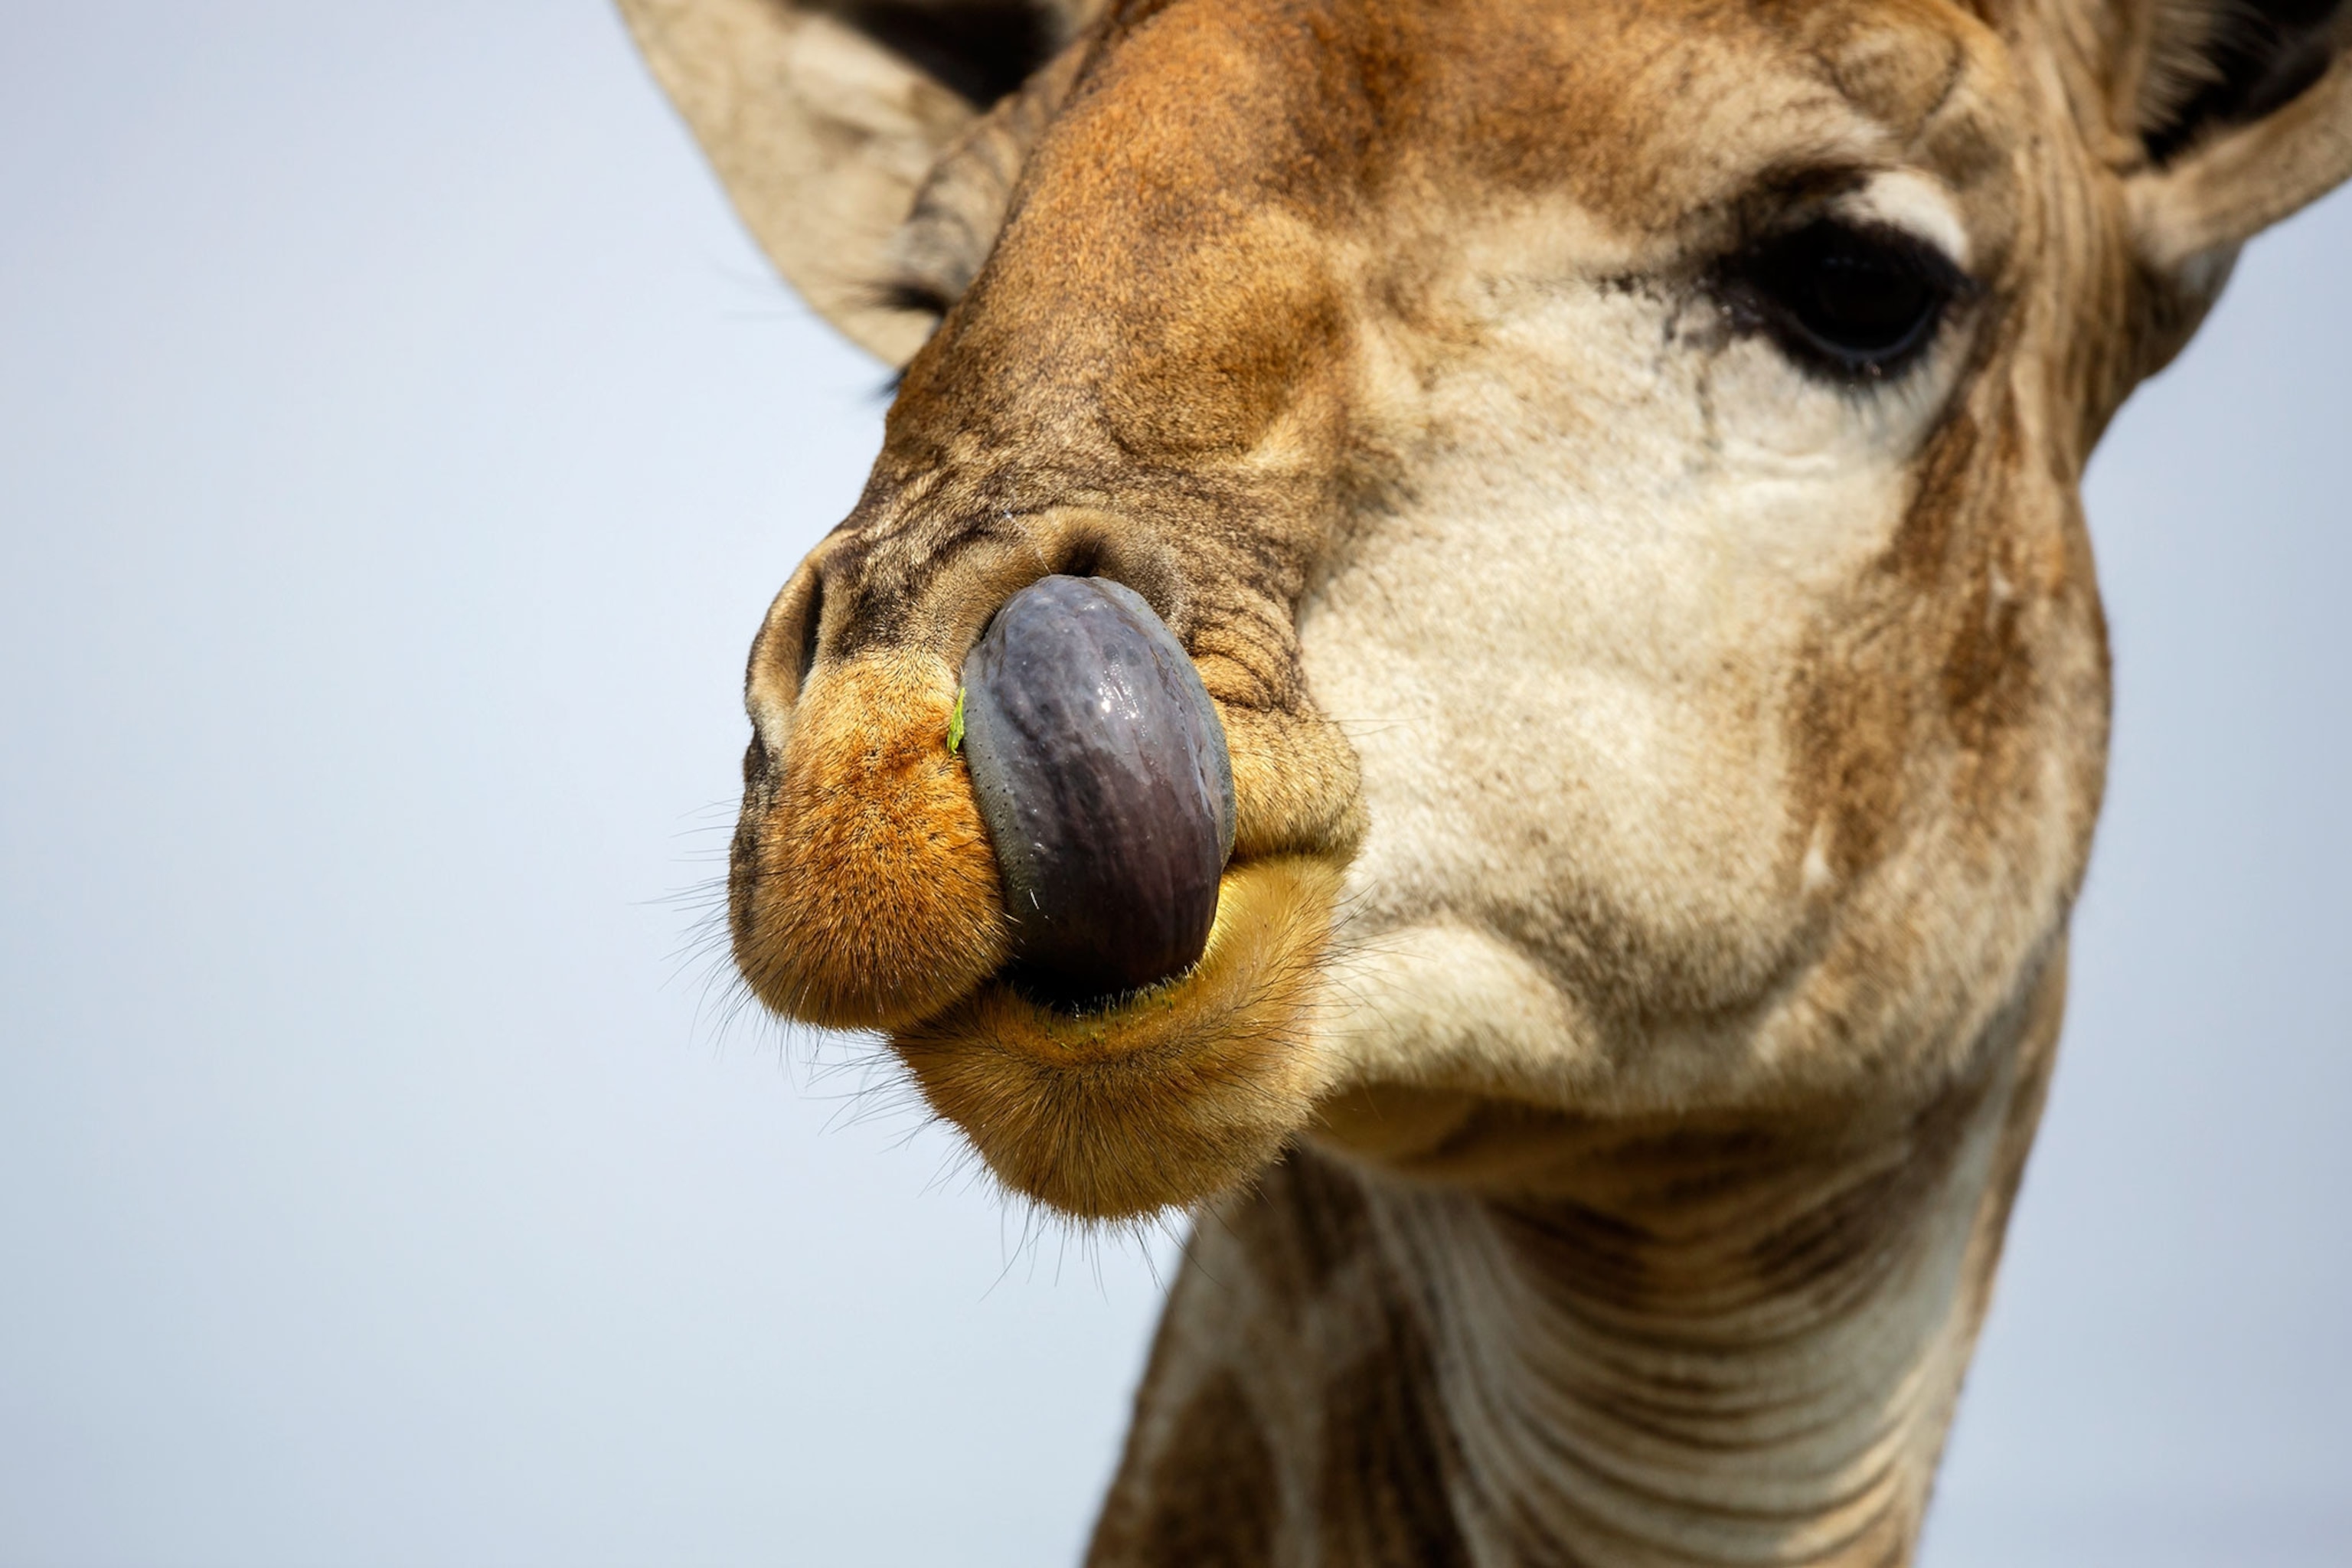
[891,856,1341,1220]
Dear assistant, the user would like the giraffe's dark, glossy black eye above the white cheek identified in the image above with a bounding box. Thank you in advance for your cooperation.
[1726,219,1966,381]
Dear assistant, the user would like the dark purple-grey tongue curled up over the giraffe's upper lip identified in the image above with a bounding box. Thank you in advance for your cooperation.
[965,576,1233,1001]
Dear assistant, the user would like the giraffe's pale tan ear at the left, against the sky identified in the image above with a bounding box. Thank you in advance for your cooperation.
[619,0,1080,364]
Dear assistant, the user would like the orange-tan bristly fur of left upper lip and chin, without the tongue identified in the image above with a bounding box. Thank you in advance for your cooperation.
[731,620,1345,1218]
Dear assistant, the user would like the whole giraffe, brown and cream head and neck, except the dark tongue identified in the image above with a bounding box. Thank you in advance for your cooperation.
[623,0,2352,1568]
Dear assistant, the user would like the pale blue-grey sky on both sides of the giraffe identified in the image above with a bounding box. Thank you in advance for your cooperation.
[0,0,2352,1568]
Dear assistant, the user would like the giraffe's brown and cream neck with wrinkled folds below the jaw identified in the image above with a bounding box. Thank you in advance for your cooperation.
[1089,991,2056,1568]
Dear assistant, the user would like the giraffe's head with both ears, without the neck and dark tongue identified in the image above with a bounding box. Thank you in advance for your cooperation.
[626,0,2352,1215]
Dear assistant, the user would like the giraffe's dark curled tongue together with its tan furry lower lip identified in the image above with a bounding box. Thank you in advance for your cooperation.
[893,576,1336,1218]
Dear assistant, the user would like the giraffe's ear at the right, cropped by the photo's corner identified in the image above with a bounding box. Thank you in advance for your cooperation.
[2119,0,2352,276]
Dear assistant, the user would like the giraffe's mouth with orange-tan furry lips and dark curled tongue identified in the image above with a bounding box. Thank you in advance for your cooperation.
[729,578,1345,1218]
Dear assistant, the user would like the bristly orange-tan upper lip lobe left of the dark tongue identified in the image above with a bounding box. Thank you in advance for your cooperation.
[731,648,1004,1030]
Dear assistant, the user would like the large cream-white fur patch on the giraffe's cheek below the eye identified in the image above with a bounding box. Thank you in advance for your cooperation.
[1301,202,1959,1107]
